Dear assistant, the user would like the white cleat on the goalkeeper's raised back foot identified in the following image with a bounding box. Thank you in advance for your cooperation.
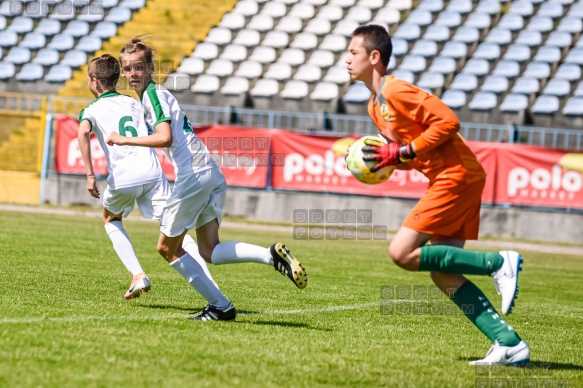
[492,251,523,315]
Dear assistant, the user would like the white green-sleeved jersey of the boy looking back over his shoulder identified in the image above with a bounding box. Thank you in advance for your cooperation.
[140,81,218,179]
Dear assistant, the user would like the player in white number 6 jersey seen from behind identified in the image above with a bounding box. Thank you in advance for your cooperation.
[78,54,233,310]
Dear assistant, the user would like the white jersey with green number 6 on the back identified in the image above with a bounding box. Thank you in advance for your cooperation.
[79,91,165,190]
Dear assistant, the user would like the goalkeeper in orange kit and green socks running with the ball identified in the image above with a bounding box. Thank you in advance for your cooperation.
[346,25,530,364]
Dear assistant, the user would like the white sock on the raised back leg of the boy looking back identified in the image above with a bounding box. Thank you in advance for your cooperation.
[211,241,273,266]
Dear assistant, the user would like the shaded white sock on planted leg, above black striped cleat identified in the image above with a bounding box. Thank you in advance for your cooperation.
[170,253,231,310]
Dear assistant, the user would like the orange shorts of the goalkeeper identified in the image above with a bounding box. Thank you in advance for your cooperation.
[403,179,486,241]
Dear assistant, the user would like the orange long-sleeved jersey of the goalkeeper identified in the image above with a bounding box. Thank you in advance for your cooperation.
[368,75,486,184]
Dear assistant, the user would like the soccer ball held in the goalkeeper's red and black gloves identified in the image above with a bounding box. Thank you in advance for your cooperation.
[346,136,395,185]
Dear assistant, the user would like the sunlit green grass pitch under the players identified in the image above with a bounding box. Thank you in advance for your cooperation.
[0,212,583,387]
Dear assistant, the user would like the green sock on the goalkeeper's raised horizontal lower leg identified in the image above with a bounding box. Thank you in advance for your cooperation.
[419,245,504,275]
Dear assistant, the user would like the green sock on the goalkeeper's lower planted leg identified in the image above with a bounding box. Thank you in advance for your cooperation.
[451,280,520,346]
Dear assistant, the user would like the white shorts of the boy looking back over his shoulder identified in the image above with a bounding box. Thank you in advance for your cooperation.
[160,168,227,237]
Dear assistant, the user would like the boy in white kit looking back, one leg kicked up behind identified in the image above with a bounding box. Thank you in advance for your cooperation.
[107,37,307,320]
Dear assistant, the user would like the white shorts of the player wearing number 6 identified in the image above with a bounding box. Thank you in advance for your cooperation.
[103,179,170,220]
